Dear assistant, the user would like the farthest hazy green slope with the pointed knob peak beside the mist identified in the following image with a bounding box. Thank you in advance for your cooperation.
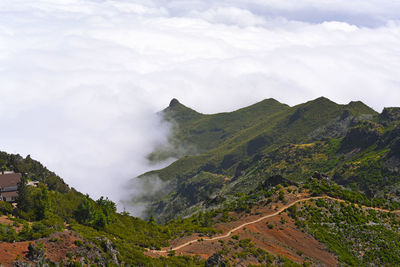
[149,99,289,161]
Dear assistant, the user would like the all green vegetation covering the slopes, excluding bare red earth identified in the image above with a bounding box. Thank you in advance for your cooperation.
[0,98,400,266]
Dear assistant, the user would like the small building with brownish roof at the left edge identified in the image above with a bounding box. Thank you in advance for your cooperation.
[0,172,22,202]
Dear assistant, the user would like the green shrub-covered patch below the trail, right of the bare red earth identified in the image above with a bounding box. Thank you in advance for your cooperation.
[291,199,400,266]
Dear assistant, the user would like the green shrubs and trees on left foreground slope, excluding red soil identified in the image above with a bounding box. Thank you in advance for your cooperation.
[0,152,215,266]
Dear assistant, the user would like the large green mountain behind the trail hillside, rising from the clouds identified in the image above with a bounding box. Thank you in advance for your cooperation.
[136,97,400,221]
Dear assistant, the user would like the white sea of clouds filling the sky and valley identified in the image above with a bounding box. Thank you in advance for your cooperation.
[0,0,400,214]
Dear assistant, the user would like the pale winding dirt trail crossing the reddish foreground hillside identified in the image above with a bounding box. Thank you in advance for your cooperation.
[149,196,400,253]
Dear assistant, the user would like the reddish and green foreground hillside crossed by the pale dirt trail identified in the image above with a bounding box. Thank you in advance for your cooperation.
[146,182,400,266]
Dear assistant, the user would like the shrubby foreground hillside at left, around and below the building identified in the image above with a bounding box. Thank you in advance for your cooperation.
[0,152,213,266]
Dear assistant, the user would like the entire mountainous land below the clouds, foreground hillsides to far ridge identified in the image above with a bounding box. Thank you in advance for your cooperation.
[0,98,400,266]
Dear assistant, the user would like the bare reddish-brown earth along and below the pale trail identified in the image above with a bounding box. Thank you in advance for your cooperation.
[147,195,338,266]
